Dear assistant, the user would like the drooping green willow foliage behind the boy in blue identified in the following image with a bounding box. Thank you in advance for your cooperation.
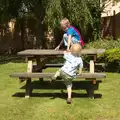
[44,0,101,39]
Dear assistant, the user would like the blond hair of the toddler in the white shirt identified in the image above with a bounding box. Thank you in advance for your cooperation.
[70,43,82,57]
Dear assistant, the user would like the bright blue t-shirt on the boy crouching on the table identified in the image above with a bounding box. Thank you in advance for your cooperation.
[66,27,80,40]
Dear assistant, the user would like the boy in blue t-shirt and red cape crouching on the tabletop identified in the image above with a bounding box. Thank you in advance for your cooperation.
[55,18,84,51]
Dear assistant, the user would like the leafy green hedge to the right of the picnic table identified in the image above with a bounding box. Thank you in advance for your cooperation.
[84,39,120,72]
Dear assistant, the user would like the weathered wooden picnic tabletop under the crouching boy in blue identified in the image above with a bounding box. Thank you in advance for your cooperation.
[18,49,105,56]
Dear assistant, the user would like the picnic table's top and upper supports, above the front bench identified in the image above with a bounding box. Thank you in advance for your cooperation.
[18,49,105,73]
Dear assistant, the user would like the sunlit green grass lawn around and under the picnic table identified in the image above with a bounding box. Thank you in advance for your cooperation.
[0,63,120,120]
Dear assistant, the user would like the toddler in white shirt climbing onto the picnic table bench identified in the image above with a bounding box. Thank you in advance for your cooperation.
[52,44,83,104]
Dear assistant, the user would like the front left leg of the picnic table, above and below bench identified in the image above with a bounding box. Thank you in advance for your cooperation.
[25,58,32,98]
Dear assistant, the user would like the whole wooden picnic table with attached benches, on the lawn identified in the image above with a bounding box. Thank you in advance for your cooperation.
[10,49,106,98]
